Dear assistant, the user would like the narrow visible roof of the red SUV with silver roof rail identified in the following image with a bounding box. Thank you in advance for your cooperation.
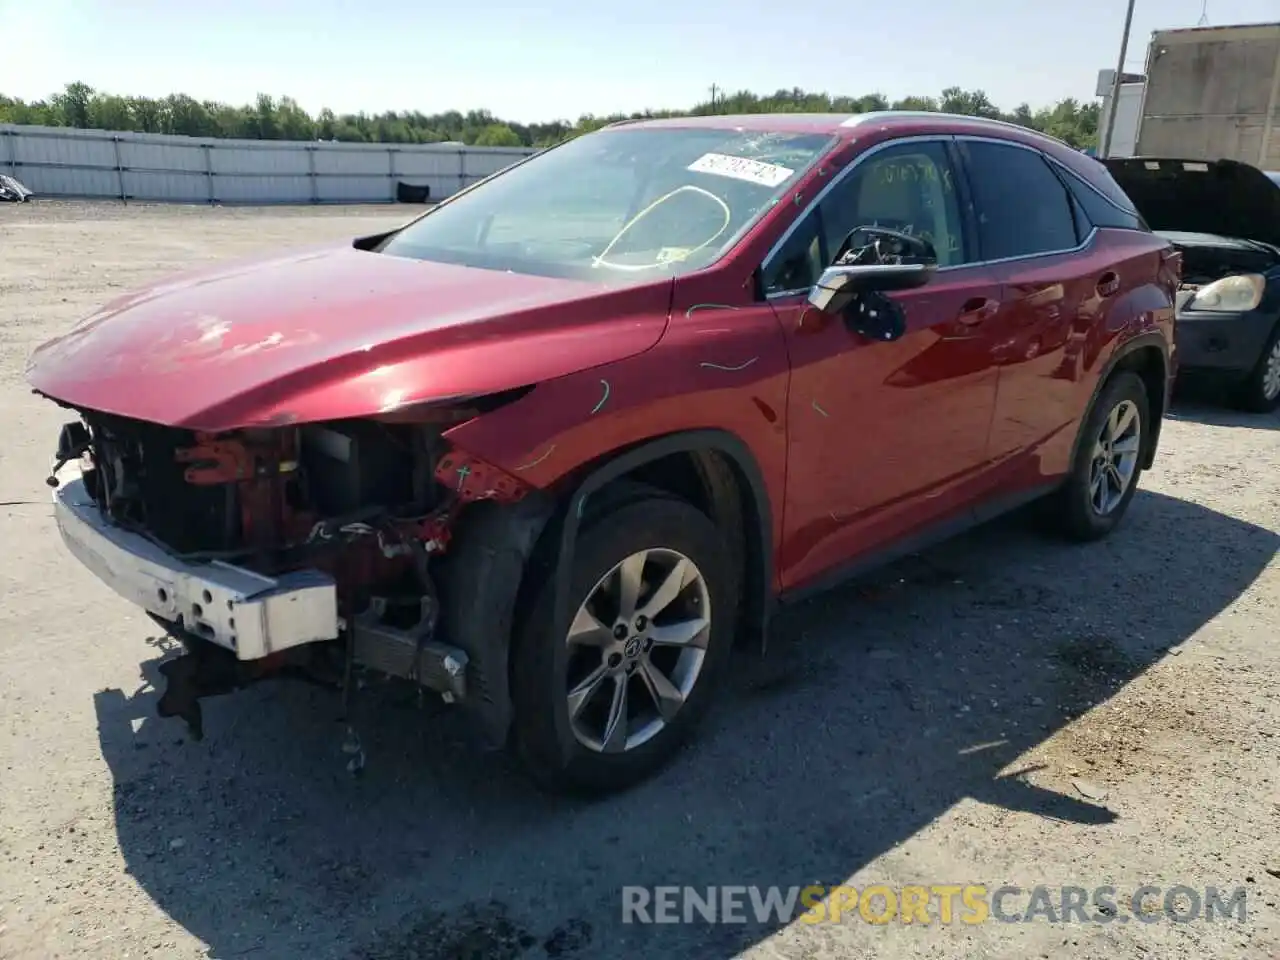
[605,110,1061,143]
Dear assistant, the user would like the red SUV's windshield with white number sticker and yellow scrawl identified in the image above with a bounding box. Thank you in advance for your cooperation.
[381,128,835,283]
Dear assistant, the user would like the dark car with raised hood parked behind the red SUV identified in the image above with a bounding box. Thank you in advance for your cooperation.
[1106,157,1280,412]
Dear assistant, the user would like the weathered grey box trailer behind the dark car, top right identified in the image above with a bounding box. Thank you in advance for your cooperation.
[1135,23,1280,170]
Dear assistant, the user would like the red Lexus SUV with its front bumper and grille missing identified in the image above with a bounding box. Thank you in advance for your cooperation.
[27,113,1180,790]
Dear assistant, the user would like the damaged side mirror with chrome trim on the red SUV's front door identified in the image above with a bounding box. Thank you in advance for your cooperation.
[809,227,938,340]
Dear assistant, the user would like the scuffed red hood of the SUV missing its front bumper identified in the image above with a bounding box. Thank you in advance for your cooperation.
[27,244,672,431]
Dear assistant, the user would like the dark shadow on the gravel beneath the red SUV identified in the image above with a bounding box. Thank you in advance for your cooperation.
[96,492,1280,960]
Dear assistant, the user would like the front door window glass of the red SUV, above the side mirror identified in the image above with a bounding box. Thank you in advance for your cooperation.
[763,142,973,293]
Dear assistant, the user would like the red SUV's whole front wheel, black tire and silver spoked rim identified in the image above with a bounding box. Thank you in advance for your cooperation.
[512,495,737,792]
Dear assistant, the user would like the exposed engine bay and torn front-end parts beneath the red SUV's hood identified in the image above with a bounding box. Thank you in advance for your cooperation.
[49,397,529,737]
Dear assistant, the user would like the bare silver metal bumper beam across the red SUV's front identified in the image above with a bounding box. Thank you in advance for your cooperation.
[54,479,339,660]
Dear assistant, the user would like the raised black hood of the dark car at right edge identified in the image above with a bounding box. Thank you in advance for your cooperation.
[1102,156,1280,246]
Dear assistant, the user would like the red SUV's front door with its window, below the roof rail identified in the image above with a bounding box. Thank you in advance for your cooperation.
[762,138,1001,589]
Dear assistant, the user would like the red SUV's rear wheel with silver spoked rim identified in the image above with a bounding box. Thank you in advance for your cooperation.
[1050,370,1151,543]
